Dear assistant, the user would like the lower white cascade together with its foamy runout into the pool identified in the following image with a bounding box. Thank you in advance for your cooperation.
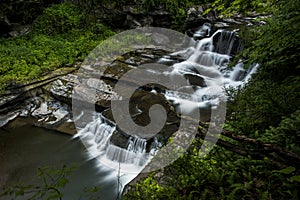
[75,114,154,196]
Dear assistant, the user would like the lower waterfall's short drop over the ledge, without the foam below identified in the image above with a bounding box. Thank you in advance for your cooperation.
[75,114,149,172]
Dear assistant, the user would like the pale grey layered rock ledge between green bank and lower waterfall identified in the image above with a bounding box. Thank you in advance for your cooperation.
[57,49,166,110]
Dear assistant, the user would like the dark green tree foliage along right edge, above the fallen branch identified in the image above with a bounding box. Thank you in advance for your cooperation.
[230,0,300,141]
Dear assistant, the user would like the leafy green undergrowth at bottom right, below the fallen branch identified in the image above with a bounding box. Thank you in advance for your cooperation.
[124,144,299,199]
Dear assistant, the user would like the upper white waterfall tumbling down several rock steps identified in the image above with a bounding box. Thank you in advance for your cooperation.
[165,30,258,114]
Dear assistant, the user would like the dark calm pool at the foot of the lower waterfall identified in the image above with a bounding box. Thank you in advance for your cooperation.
[0,118,117,200]
